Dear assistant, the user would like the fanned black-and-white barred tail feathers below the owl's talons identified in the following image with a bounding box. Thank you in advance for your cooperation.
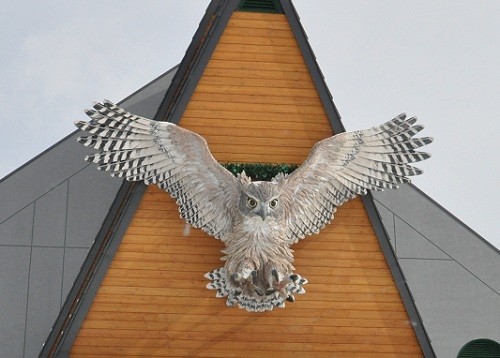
[205,267,307,312]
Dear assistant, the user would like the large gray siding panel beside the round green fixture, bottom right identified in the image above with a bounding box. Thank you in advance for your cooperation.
[400,259,500,358]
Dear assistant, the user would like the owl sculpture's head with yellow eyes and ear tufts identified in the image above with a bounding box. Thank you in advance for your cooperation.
[238,172,287,221]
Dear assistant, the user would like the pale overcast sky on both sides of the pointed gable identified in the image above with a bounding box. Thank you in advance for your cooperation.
[0,0,500,247]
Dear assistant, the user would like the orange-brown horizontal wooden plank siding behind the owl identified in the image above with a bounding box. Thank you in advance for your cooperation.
[71,12,422,357]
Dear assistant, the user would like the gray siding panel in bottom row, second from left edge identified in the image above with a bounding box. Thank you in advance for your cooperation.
[25,247,64,357]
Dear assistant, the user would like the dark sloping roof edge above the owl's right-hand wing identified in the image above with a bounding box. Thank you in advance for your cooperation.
[280,0,345,134]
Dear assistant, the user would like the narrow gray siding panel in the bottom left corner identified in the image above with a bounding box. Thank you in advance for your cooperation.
[0,246,31,358]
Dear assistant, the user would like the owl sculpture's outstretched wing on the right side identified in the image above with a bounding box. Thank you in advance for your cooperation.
[284,114,433,243]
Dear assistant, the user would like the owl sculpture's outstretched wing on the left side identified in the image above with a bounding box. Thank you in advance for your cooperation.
[75,101,238,240]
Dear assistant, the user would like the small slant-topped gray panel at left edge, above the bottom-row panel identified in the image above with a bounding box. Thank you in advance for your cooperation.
[0,204,34,246]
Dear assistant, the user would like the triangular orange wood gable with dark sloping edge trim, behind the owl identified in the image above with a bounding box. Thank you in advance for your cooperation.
[42,1,433,356]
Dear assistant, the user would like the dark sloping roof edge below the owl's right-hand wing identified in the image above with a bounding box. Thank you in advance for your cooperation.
[361,192,436,357]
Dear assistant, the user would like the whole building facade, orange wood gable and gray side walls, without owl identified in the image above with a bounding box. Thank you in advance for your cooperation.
[0,0,500,357]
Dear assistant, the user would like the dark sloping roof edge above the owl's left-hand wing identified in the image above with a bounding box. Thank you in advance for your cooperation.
[154,0,239,124]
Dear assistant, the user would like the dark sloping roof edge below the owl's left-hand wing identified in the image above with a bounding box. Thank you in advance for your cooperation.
[39,181,147,357]
